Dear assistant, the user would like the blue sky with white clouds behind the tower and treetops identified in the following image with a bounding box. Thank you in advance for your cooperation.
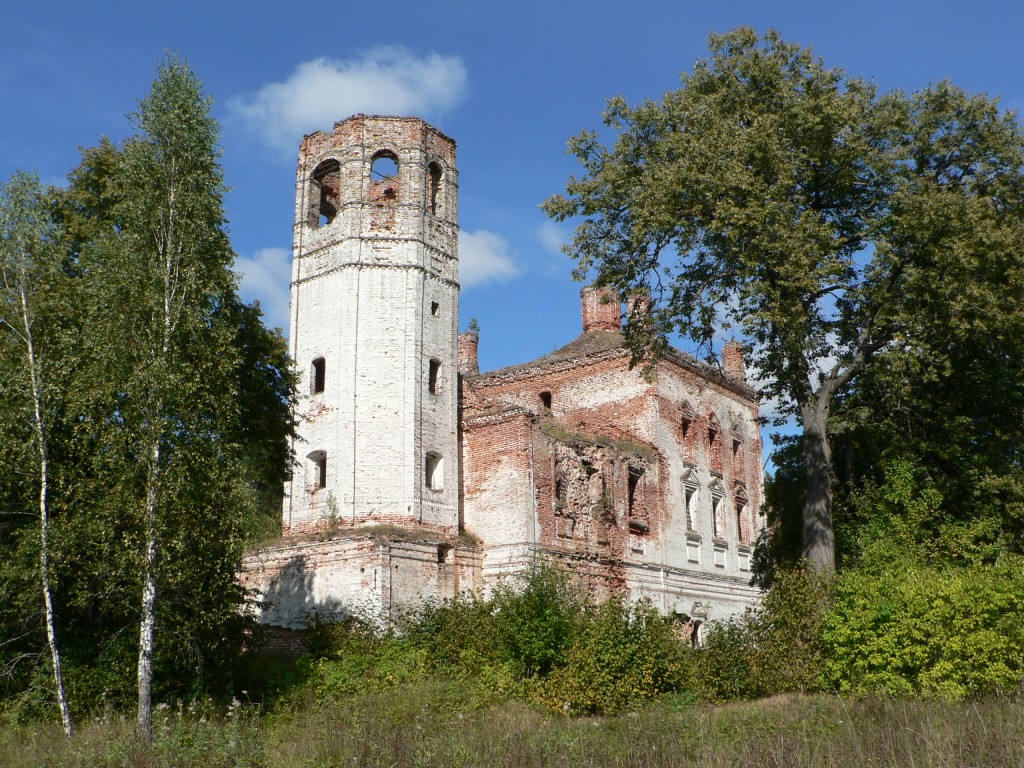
[0,0,1024,462]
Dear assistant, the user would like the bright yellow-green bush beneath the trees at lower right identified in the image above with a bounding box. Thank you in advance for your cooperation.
[822,557,1024,698]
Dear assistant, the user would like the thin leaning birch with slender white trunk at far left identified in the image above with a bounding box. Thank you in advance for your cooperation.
[0,173,74,737]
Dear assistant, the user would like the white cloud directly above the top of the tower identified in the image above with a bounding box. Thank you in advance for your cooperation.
[227,46,467,152]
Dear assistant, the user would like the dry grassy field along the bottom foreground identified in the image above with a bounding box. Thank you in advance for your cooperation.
[0,683,1024,768]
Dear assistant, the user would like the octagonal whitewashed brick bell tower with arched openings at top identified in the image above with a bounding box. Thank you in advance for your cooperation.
[284,115,459,532]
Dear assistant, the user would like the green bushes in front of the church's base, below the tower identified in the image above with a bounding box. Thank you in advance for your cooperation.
[306,566,690,714]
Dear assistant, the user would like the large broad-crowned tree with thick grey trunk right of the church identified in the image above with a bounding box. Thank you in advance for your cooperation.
[545,28,1024,571]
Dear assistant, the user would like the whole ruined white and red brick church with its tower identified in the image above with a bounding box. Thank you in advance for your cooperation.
[243,115,764,632]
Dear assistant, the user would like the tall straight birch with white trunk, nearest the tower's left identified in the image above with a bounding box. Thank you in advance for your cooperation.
[104,58,237,738]
